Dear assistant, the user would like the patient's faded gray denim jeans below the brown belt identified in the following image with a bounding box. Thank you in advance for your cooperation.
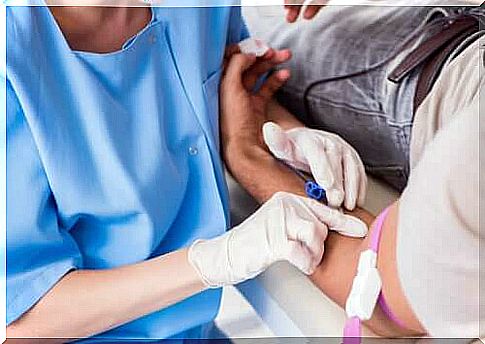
[248,6,480,190]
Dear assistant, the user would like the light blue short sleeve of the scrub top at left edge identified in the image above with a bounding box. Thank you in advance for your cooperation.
[6,80,81,325]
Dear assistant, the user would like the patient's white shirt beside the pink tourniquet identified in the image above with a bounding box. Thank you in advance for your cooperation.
[397,36,485,338]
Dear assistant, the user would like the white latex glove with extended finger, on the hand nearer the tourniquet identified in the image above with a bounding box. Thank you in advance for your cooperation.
[188,193,367,288]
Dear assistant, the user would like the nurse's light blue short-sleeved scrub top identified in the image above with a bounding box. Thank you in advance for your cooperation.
[7,7,248,339]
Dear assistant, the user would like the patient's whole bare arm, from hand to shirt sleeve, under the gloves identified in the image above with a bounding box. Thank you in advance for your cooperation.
[221,52,424,336]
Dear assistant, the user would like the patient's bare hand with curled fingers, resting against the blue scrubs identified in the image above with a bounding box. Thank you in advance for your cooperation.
[220,46,290,157]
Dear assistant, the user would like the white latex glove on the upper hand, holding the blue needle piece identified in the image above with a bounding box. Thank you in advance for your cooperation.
[263,122,367,210]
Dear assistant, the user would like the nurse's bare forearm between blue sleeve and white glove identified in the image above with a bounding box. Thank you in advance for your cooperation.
[7,250,205,343]
